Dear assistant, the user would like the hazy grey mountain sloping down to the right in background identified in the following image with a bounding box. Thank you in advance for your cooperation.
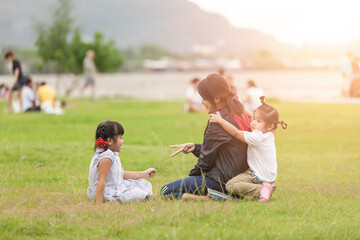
[0,0,294,55]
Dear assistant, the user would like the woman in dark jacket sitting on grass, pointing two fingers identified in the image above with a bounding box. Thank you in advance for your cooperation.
[160,74,250,199]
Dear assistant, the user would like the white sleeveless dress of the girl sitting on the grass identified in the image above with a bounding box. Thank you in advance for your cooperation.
[87,149,153,202]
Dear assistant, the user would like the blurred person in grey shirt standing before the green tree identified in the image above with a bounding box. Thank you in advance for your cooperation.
[80,49,98,100]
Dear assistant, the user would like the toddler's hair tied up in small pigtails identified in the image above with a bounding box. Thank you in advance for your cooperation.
[254,96,287,130]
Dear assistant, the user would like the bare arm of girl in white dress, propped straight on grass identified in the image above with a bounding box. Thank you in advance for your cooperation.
[96,158,112,204]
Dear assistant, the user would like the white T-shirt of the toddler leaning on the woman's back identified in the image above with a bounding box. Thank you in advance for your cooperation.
[244,130,277,182]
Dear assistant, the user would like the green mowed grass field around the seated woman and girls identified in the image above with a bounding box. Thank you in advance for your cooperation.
[0,99,360,239]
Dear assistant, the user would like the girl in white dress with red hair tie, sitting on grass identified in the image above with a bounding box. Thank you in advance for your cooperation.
[87,121,156,204]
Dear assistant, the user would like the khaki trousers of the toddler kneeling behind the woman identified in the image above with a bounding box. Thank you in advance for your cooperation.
[226,171,262,197]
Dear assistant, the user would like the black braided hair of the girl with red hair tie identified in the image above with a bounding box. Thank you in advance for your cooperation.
[94,120,125,151]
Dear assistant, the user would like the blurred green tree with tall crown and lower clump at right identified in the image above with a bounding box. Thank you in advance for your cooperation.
[35,0,123,94]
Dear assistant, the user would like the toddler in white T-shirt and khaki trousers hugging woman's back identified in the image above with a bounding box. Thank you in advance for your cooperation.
[210,97,287,202]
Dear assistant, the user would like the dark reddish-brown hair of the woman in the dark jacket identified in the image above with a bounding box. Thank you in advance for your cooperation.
[198,73,244,116]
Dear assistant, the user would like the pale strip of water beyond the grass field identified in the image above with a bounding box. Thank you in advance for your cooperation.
[0,71,358,102]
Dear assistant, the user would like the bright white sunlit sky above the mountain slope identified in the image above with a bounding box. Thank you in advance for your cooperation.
[189,0,360,45]
